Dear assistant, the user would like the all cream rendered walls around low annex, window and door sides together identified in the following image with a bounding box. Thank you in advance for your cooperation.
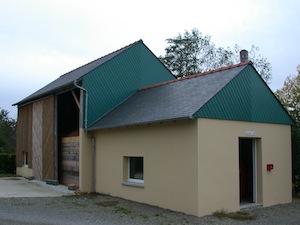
[79,119,292,216]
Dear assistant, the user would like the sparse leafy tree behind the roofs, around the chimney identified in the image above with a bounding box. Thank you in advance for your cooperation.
[159,29,272,82]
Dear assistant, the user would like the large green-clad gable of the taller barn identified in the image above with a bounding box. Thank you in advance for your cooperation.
[82,41,175,126]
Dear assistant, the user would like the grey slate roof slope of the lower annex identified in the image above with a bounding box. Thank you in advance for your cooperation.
[89,64,247,130]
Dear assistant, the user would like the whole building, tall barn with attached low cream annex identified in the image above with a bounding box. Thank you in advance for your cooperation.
[16,41,293,216]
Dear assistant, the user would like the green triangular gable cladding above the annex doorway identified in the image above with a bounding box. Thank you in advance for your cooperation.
[193,65,294,125]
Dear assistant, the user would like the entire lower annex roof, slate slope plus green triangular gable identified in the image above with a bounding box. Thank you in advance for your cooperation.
[89,62,293,130]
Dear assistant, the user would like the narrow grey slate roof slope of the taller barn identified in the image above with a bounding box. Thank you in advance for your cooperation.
[14,40,142,105]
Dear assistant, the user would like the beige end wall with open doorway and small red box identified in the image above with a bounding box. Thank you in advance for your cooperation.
[198,119,292,215]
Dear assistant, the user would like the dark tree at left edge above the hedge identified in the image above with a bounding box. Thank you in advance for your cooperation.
[0,108,16,152]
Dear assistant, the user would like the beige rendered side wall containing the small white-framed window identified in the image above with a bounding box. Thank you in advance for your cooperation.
[94,121,198,215]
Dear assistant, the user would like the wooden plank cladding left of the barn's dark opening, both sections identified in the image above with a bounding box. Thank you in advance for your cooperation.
[16,96,56,180]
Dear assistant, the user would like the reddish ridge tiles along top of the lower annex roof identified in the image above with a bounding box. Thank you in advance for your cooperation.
[138,60,253,91]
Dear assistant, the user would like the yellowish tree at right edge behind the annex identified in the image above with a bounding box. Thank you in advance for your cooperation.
[275,65,300,193]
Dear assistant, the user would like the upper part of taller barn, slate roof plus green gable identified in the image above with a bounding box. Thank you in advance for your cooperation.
[15,40,175,126]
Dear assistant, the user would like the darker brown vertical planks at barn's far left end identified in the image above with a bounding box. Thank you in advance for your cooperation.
[16,104,32,168]
